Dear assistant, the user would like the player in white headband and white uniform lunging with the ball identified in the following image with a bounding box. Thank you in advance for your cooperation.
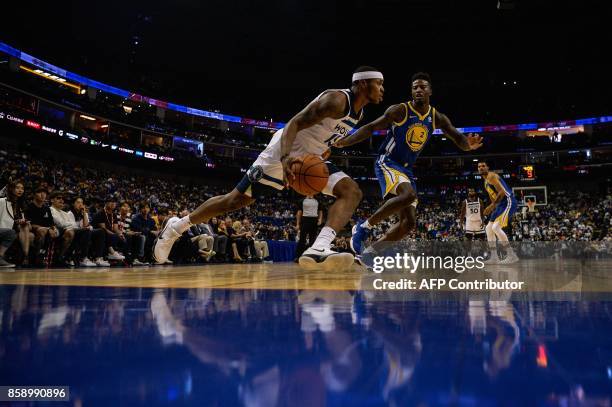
[153,67,384,270]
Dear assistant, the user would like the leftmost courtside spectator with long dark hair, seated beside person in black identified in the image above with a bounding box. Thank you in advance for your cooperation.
[4,181,34,266]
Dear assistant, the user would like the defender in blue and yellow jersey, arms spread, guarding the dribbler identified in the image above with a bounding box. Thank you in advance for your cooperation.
[336,72,482,254]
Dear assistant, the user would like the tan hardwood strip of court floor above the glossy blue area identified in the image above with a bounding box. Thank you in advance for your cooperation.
[0,260,612,292]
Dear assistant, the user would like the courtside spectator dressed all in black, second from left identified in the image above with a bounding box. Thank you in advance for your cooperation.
[25,186,58,265]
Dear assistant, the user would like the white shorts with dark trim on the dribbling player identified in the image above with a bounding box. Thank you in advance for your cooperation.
[236,155,349,197]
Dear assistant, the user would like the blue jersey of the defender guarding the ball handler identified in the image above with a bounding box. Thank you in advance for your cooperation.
[378,102,436,168]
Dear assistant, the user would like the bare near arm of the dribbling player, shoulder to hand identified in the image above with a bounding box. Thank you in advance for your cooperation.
[281,92,347,184]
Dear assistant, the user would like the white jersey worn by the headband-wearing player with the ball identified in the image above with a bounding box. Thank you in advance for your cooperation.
[259,89,363,161]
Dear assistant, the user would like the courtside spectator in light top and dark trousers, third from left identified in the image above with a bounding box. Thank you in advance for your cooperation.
[51,192,96,267]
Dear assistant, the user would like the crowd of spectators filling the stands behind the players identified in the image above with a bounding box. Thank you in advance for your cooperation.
[0,145,612,267]
